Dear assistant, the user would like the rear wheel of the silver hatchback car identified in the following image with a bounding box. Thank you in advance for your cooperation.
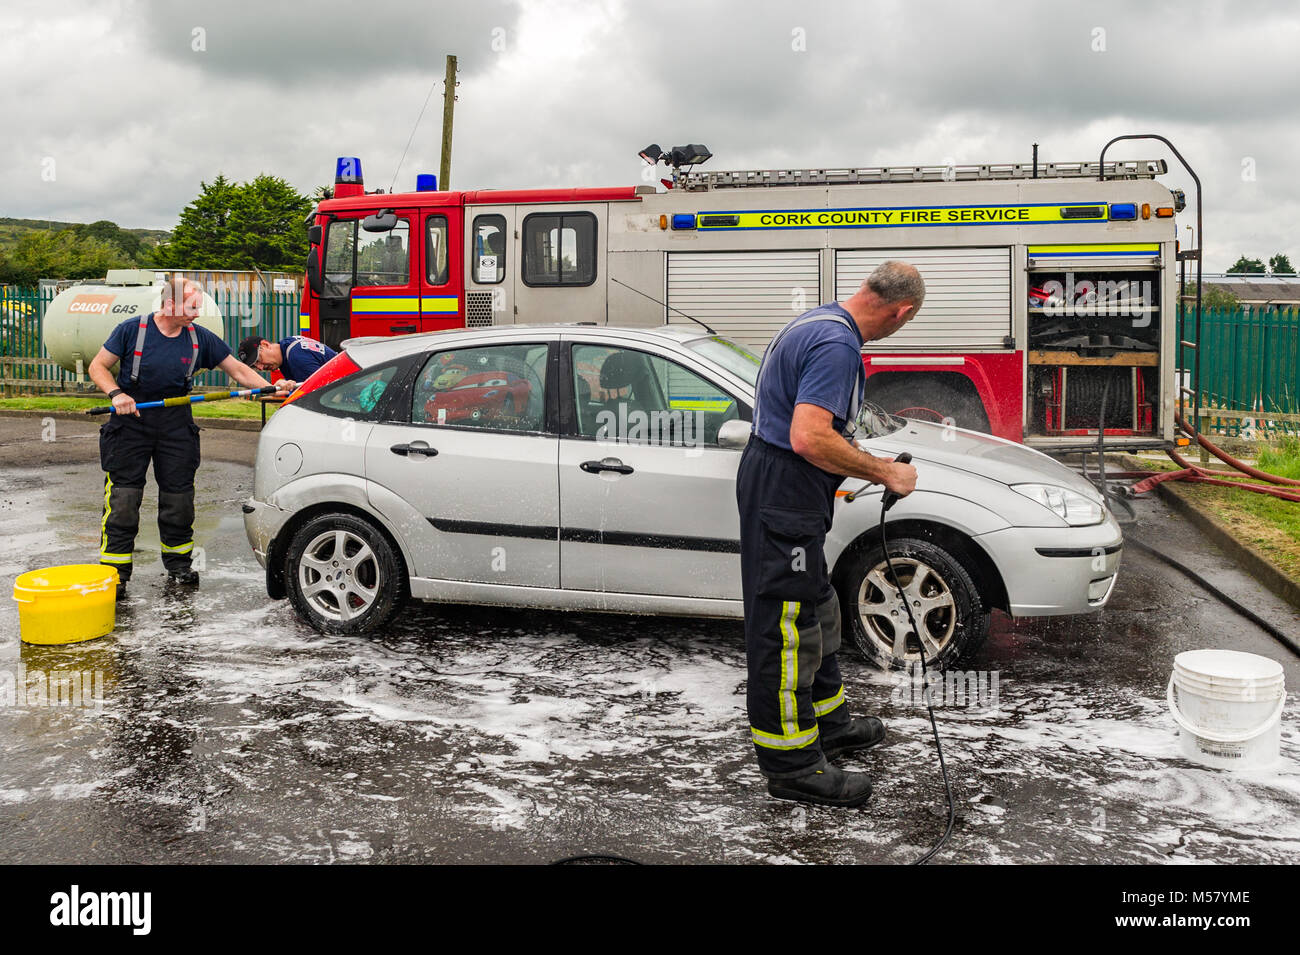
[285,513,404,634]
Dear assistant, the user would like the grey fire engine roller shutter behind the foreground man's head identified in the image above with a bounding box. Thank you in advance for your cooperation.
[835,248,1011,351]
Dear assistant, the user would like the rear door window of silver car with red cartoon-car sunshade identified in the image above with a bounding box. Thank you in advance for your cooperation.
[411,342,547,431]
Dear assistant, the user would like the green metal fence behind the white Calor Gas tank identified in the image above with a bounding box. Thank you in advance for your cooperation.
[0,287,299,391]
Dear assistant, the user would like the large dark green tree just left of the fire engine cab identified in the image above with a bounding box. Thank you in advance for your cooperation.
[153,175,312,272]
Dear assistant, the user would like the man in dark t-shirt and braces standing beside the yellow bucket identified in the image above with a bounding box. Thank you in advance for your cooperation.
[90,278,295,598]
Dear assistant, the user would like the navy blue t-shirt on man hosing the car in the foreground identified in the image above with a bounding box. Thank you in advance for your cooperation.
[754,301,866,451]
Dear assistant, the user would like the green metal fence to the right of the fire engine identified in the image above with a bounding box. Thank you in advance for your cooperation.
[1182,308,1300,434]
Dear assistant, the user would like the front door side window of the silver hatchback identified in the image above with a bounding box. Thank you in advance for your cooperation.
[572,344,740,447]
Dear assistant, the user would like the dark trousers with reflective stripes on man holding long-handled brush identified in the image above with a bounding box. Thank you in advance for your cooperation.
[99,408,199,581]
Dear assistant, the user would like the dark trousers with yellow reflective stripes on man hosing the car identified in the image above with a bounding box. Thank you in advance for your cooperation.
[736,435,849,778]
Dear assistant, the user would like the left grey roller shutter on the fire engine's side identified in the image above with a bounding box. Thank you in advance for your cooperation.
[668,249,822,352]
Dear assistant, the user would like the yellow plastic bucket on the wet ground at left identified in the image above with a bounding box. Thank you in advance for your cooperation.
[13,564,117,643]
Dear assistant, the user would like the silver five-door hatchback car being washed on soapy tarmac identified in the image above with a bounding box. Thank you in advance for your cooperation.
[243,325,1122,667]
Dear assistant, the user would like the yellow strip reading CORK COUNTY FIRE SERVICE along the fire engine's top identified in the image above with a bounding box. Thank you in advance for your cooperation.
[697,203,1106,231]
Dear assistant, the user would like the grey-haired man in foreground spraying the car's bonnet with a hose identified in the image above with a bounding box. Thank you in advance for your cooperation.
[736,261,926,806]
